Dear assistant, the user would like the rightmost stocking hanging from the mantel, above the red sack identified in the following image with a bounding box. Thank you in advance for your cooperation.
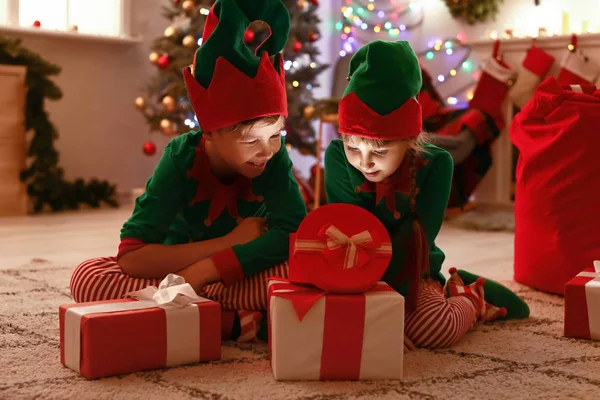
[556,35,600,86]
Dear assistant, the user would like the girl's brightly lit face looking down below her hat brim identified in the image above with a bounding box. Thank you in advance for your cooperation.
[344,140,410,182]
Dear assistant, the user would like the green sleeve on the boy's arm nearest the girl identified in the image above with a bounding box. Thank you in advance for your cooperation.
[233,140,306,276]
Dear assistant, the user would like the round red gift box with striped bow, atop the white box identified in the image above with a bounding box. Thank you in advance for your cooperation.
[289,204,392,293]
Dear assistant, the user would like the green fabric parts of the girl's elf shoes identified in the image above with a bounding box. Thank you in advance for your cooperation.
[456,269,529,319]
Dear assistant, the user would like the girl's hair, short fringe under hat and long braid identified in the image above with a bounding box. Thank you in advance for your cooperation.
[342,132,429,310]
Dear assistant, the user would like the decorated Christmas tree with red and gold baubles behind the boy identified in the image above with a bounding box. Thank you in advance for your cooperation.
[135,0,328,155]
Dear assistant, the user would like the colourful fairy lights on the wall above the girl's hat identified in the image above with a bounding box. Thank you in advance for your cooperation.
[335,0,479,105]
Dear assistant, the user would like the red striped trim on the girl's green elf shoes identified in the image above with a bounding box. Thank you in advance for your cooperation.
[446,268,506,322]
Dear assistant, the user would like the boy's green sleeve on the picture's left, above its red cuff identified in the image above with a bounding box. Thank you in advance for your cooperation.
[121,143,185,243]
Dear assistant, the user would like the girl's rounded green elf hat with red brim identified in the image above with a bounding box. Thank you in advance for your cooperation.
[339,40,423,140]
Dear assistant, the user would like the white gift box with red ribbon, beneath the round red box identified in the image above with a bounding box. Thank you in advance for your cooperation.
[268,279,404,380]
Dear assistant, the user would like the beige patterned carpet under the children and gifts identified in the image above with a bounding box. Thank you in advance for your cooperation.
[0,260,600,400]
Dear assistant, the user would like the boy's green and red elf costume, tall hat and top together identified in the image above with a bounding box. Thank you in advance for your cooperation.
[117,0,306,286]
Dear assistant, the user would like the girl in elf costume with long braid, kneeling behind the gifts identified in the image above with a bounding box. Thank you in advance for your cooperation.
[325,41,529,348]
